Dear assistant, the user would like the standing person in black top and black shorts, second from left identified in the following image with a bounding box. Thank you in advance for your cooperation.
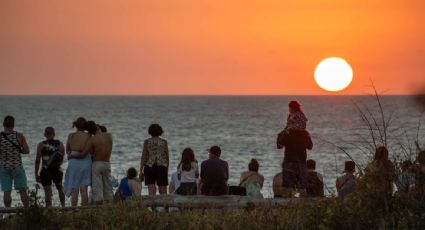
[35,127,65,207]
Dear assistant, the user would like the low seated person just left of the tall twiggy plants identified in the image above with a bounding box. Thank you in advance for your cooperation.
[336,161,357,198]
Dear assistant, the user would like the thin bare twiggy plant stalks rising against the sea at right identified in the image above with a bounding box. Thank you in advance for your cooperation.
[315,82,425,191]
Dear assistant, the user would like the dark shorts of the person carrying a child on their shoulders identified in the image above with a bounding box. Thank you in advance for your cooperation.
[282,162,307,189]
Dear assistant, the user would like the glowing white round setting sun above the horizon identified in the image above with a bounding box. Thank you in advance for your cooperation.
[314,57,353,92]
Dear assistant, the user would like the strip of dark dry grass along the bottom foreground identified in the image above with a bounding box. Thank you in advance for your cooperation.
[0,190,425,230]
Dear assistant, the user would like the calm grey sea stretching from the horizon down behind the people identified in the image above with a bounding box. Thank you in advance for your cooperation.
[0,96,425,205]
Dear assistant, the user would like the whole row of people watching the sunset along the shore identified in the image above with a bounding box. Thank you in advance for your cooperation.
[0,101,425,207]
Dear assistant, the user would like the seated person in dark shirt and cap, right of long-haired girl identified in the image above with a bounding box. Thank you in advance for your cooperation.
[201,146,229,196]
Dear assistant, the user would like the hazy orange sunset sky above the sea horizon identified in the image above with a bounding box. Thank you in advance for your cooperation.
[0,0,425,95]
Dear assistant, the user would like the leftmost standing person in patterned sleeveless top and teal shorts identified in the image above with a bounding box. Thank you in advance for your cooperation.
[0,116,29,208]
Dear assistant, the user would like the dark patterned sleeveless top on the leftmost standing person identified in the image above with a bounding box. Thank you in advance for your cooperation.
[0,131,22,169]
